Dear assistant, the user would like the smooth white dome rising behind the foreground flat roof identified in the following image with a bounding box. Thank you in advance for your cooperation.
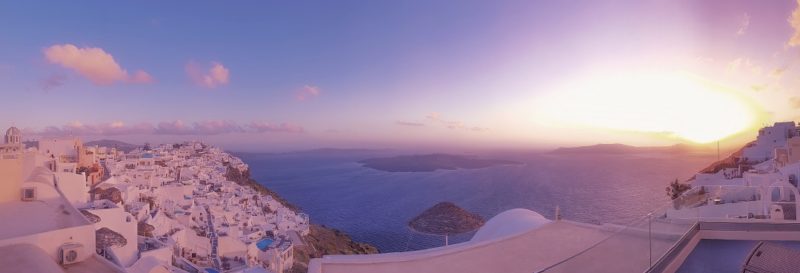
[470,209,550,241]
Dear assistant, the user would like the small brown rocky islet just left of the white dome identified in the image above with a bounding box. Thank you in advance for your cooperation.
[408,202,485,245]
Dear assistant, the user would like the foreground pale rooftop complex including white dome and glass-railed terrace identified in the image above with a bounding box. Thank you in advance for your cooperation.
[309,185,800,273]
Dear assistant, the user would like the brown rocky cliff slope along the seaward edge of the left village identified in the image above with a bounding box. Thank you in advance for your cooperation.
[225,163,378,273]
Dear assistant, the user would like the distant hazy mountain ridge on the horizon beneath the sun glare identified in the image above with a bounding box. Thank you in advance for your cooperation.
[549,143,712,154]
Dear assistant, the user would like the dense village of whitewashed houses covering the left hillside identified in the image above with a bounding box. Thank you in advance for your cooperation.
[0,127,309,273]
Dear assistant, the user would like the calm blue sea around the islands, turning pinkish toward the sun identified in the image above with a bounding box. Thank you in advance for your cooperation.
[236,151,714,252]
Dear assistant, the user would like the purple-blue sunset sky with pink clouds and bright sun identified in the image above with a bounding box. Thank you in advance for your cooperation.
[0,0,800,151]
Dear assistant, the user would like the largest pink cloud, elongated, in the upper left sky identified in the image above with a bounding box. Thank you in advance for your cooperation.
[44,44,153,85]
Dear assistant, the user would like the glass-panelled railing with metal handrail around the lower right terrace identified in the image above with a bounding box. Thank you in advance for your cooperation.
[534,186,798,272]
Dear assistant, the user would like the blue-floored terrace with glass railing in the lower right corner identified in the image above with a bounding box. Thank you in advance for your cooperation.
[536,185,800,272]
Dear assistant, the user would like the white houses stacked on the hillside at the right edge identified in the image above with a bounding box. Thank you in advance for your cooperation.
[666,122,800,221]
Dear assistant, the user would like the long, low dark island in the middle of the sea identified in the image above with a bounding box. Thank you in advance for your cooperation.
[359,154,521,172]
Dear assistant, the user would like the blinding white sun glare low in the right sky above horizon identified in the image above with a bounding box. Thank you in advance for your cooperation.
[538,73,757,143]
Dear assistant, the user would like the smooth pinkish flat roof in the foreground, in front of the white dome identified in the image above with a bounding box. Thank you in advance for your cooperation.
[309,221,620,273]
